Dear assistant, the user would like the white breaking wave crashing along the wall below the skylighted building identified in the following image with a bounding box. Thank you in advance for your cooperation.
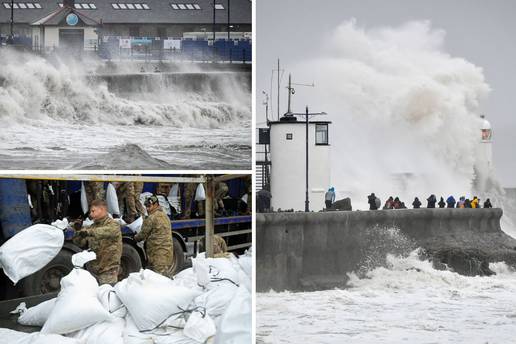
[0,51,251,128]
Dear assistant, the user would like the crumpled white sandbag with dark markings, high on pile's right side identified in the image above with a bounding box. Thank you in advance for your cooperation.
[192,256,239,289]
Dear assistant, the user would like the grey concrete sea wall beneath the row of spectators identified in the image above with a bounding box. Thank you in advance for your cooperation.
[256,209,516,291]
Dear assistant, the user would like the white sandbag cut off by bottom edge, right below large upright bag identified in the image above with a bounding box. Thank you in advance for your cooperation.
[68,318,125,344]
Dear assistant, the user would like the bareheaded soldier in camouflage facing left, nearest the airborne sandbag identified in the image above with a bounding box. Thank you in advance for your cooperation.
[73,200,122,285]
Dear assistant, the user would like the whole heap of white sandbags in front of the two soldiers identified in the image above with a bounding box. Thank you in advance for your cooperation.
[0,251,252,344]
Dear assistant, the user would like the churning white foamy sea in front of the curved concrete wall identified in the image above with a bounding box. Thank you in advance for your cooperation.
[256,251,516,343]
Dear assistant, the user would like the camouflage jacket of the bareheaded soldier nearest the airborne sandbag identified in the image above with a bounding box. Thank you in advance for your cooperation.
[73,216,122,274]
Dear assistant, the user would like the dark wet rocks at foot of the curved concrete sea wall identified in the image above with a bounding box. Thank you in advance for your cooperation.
[430,247,495,276]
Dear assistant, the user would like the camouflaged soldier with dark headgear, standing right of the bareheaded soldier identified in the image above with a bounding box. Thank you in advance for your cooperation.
[134,195,173,277]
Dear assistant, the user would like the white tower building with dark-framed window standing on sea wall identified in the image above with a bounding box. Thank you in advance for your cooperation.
[269,113,331,211]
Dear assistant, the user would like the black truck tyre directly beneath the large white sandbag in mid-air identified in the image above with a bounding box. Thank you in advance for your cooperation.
[22,250,73,296]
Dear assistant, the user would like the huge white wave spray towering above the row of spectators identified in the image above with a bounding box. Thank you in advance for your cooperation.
[297,20,490,204]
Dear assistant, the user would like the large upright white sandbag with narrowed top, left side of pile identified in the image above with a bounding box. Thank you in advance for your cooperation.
[41,268,111,334]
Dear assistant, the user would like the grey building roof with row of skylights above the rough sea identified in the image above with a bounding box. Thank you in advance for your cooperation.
[0,0,252,24]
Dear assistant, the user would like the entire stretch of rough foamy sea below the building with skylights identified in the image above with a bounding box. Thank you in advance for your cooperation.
[0,51,251,169]
